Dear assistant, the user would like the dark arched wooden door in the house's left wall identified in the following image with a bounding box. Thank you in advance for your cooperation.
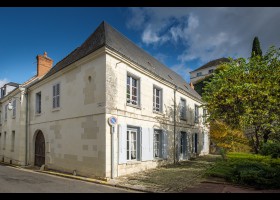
[35,131,45,167]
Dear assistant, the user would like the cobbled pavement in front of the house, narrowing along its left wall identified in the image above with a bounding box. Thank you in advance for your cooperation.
[0,158,280,193]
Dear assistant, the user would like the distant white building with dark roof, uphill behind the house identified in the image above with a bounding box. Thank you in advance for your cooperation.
[190,58,230,85]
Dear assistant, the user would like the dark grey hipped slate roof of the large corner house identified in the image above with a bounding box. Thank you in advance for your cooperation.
[43,21,201,99]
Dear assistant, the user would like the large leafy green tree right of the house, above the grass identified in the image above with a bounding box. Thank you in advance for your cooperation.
[202,47,280,153]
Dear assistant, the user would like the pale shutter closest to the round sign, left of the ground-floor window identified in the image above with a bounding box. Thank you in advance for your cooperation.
[118,124,127,164]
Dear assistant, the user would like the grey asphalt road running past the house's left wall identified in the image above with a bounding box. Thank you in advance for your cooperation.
[0,164,135,193]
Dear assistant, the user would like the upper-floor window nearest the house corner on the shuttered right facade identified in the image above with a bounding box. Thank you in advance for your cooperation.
[126,75,139,105]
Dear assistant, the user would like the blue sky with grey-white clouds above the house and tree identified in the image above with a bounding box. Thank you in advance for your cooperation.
[0,7,280,87]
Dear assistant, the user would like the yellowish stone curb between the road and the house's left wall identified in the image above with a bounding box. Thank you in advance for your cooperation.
[0,162,153,193]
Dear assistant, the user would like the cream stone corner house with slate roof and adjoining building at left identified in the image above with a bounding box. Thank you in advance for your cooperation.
[0,22,209,178]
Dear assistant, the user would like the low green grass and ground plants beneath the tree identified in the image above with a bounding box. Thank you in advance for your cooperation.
[206,153,280,189]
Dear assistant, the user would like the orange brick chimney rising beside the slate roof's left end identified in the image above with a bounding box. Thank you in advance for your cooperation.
[36,52,53,77]
